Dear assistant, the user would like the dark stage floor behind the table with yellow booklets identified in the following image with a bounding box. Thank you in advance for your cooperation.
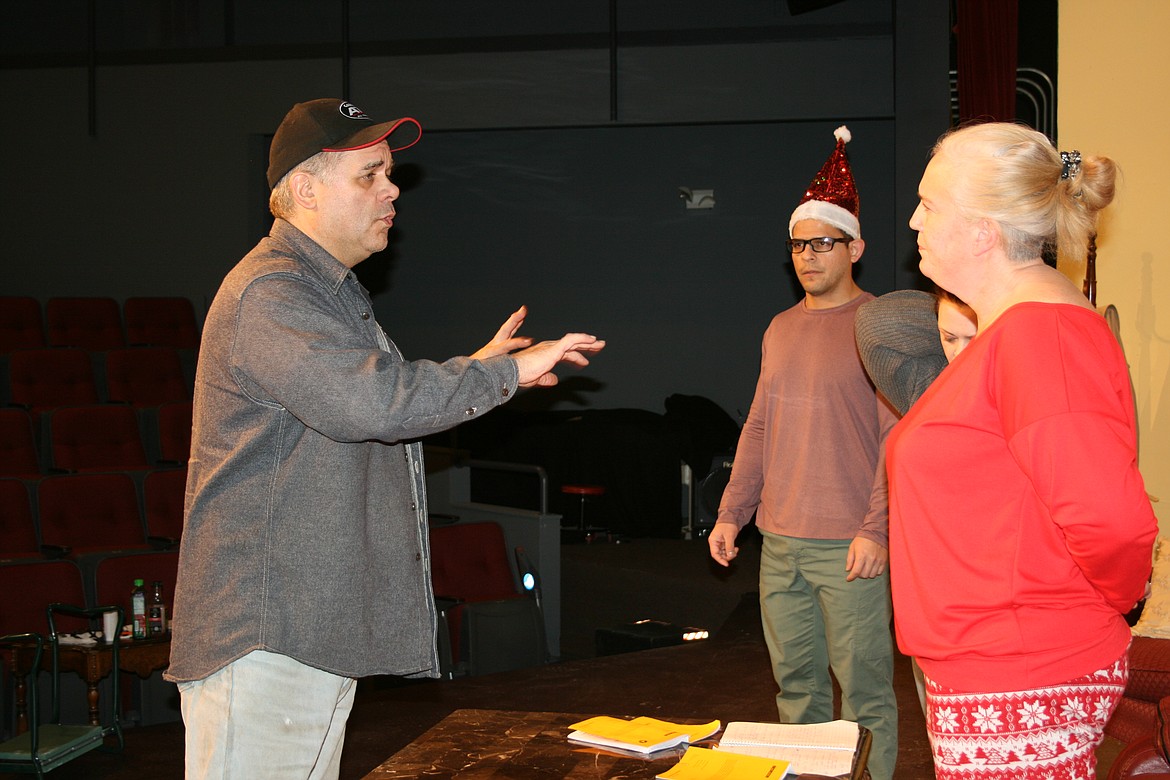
[2,539,932,780]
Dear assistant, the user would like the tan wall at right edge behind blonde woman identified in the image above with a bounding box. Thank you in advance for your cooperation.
[1058,0,1170,533]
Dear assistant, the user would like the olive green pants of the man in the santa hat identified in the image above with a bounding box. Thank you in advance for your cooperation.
[759,532,897,780]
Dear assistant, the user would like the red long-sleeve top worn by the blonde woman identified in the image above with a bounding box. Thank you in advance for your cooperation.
[887,303,1157,692]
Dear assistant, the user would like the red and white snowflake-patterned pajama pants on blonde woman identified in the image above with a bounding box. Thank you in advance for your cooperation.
[927,649,1129,780]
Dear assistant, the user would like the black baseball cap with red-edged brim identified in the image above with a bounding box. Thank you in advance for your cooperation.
[268,97,422,188]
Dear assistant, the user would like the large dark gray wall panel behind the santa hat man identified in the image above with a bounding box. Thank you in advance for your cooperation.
[369,120,898,417]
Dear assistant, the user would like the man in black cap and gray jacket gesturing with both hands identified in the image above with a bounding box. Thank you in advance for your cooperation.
[166,99,605,780]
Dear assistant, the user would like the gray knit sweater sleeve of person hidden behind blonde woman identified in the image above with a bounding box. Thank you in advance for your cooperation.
[854,290,947,414]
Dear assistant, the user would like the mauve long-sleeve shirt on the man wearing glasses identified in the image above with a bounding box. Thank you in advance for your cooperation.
[718,292,895,546]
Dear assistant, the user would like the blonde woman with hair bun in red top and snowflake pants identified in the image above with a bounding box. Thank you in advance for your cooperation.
[887,123,1157,780]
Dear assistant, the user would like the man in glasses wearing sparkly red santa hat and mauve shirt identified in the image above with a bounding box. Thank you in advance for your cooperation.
[708,127,897,780]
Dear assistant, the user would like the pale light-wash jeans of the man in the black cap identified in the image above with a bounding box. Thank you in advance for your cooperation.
[179,650,357,780]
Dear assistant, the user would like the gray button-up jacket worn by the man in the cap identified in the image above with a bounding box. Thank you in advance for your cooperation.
[166,220,517,682]
